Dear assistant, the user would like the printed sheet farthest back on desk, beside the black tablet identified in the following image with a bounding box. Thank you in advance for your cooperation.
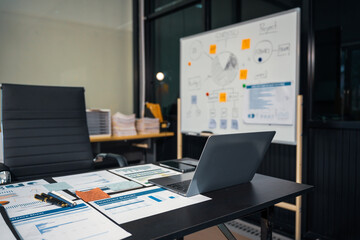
[110,164,181,186]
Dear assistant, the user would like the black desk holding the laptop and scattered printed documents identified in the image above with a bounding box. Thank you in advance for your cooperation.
[120,174,313,240]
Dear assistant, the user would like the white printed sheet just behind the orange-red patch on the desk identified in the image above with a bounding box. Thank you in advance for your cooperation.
[54,170,135,193]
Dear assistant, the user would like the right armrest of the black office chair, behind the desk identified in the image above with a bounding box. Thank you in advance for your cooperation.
[93,153,128,168]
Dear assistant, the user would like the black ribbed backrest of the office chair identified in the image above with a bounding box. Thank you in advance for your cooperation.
[2,84,93,180]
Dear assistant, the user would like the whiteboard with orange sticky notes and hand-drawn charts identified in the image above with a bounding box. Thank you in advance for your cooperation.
[180,8,300,145]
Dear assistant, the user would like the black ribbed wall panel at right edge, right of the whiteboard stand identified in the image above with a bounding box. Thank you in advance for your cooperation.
[308,129,360,239]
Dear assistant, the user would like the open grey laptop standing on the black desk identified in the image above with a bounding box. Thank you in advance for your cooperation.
[149,131,275,197]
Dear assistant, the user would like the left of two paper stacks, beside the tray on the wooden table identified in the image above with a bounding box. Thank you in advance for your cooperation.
[112,112,136,136]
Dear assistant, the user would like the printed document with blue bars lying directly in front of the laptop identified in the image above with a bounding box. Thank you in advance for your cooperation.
[90,187,211,224]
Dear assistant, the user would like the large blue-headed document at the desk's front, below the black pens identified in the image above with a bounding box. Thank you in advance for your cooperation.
[10,200,131,240]
